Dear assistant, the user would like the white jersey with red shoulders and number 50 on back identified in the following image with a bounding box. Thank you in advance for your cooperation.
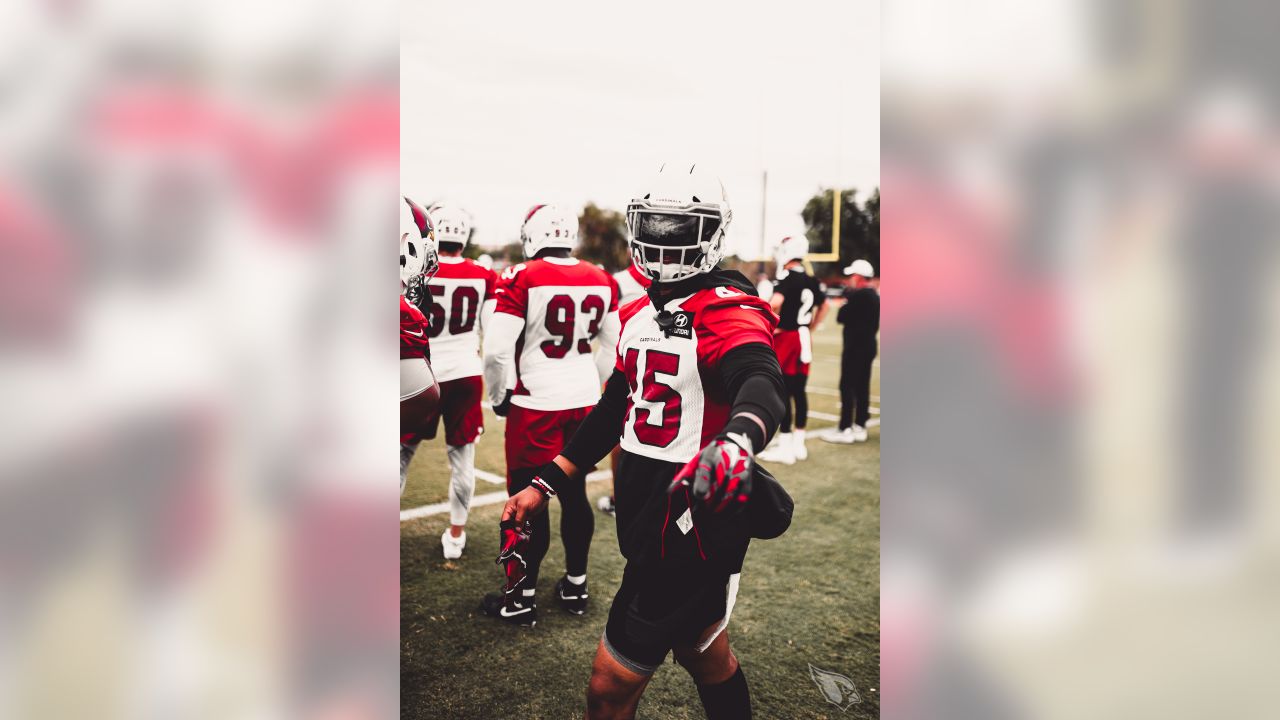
[426,258,497,383]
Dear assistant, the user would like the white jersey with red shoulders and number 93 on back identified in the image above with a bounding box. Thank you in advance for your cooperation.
[481,258,618,410]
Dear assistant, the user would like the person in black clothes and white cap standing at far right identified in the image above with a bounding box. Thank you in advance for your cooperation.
[822,260,879,445]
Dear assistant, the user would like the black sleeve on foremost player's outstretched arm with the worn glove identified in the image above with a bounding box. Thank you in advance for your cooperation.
[719,342,786,452]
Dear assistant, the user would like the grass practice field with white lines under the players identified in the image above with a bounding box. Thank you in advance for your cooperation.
[401,314,879,720]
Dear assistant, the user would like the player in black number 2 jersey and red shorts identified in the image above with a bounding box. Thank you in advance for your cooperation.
[760,236,827,465]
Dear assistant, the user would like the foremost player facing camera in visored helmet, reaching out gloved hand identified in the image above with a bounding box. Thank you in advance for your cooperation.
[503,165,785,719]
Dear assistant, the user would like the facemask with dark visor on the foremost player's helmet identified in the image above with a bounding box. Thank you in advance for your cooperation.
[627,200,727,283]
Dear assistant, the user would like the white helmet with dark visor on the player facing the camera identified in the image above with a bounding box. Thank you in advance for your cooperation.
[627,164,733,283]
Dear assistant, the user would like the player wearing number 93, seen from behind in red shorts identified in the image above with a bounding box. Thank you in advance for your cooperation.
[481,205,620,625]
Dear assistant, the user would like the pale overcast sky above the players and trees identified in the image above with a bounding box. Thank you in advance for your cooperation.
[401,0,879,256]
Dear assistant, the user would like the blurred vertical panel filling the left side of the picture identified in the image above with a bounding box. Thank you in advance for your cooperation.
[0,1,398,719]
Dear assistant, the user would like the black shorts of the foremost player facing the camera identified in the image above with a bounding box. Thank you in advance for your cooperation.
[604,562,737,675]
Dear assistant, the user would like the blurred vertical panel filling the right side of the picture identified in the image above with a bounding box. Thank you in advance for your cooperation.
[882,1,1280,720]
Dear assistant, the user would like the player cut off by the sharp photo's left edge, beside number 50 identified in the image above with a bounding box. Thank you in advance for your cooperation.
[399,197,440,495]
